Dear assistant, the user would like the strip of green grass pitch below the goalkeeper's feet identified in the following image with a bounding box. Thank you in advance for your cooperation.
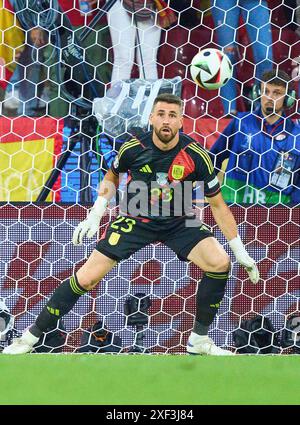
[0,354,300,405]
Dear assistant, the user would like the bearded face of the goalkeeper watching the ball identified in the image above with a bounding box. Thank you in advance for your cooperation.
[150,102,183,145]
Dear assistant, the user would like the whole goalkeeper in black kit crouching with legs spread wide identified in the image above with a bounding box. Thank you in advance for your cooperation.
[3,93,259,356]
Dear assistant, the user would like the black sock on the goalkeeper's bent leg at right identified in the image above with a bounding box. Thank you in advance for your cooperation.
[193,272,229,335]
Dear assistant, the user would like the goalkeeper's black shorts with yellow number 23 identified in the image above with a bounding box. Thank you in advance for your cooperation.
[96,216,213,261]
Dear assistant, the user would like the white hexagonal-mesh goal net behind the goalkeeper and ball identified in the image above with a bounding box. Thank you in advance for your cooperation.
[0,0,300,354]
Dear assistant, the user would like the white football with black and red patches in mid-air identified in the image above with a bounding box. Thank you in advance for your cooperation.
[190,49,232,90]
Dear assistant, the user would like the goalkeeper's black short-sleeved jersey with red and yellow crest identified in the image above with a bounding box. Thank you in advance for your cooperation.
[111,132,220,220]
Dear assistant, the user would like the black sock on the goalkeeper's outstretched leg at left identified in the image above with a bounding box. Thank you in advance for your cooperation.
[30,275,87,338]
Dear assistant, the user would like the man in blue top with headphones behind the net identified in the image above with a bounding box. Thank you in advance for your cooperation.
[211,70,300,205]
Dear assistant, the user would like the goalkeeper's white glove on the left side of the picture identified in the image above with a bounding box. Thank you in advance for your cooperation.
[72,196,108,245]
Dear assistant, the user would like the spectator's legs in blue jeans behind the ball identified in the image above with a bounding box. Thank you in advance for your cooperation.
[211,0,273,115]
